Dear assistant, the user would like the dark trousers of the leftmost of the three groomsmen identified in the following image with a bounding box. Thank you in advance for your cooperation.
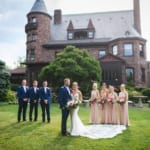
[18,100,28,121]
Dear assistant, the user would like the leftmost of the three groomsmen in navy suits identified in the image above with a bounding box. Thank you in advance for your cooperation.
[17,79,28,122]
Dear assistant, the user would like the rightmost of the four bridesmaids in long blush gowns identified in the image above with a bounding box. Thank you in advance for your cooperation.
[119,84,129,126]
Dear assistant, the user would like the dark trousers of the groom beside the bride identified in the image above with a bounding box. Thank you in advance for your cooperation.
[61,108,69,134]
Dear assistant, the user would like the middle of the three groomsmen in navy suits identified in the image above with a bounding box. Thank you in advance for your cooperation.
[28,80,39,121]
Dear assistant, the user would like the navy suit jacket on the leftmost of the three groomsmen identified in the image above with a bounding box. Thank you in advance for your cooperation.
[17,86,28,103]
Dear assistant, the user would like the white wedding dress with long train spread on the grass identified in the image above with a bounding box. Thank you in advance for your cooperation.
[70,93,126,139]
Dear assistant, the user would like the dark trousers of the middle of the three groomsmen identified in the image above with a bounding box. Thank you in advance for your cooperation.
[29,102,38,121]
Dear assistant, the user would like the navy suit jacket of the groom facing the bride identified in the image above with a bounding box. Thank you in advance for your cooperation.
[58,86,71,108]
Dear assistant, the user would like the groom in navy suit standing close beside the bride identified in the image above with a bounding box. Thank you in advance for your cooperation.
[58,78,71,136]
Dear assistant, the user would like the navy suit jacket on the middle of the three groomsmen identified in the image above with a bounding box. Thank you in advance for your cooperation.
[28,87,39,102]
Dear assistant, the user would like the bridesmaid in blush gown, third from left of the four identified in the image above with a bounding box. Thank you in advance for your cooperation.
[107,86,118,124]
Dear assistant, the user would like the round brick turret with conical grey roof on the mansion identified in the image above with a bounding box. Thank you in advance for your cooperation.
[25,0,51,84]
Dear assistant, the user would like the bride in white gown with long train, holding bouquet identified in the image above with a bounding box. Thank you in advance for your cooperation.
[69,82,126,139]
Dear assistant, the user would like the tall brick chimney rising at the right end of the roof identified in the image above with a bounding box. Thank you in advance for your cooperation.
[133,0,141,34]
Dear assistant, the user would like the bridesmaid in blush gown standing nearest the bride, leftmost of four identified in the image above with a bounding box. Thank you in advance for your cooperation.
[90,83,100,124]
